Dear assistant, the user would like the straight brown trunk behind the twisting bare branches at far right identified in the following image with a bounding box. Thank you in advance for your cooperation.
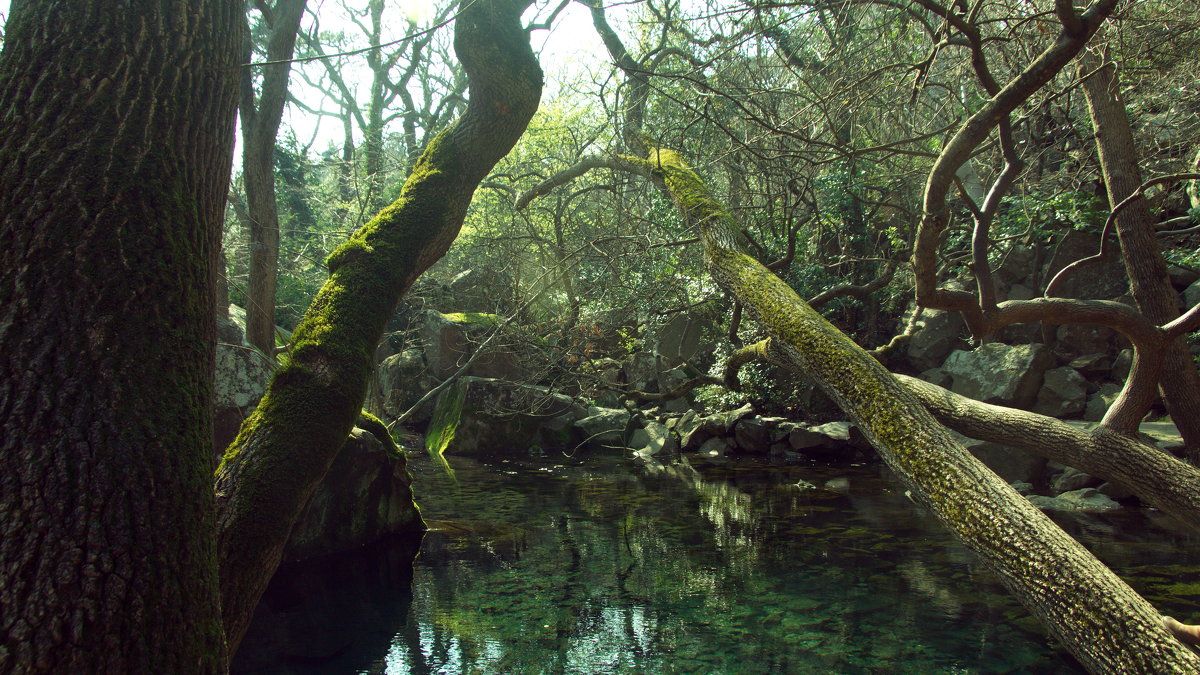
[1079,52,1200,462]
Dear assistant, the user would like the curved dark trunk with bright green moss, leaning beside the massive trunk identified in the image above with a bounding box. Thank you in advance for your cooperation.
[216,0,541,650]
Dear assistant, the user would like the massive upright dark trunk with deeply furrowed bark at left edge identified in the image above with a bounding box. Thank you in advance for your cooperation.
[0,0,242,673]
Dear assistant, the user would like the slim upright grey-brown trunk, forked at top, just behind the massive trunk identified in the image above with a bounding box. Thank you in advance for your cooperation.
[239,0,306,357]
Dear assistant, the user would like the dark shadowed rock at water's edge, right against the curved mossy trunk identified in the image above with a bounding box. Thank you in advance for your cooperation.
[283,429,422,561]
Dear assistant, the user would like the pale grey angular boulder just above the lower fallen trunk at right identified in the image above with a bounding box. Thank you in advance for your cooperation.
[942,342,1054,408]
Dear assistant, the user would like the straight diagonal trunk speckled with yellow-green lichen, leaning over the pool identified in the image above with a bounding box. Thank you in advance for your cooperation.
[643,149,1200,673]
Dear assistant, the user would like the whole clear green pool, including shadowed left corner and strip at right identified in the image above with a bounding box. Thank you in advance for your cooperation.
[235,449,1200,675]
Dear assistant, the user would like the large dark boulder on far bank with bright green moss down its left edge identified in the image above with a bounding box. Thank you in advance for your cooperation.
[438,377,588,455]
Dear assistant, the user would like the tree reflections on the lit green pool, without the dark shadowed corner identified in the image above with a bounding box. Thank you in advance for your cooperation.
[388,454,1094,673]
